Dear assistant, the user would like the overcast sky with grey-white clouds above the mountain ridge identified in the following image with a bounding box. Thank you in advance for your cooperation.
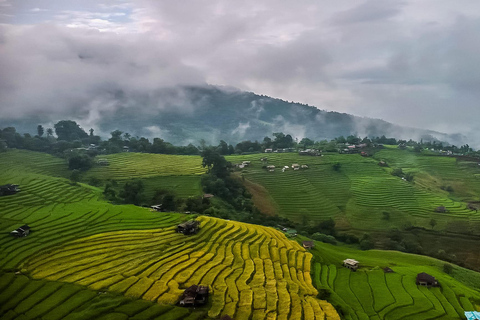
[0,0,480,142]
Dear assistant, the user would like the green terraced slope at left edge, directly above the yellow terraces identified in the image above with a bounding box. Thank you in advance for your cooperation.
[0,151,185,268]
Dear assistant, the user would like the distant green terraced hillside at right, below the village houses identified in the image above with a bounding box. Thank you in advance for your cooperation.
[228,150,480,234]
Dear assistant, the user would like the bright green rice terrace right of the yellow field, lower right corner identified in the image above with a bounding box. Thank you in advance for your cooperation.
[312,243,480,320]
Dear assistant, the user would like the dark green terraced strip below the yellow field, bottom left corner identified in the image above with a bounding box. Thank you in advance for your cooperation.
[0,273,206,320]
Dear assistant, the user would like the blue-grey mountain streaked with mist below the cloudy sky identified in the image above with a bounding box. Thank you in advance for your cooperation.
[0,85,466,145]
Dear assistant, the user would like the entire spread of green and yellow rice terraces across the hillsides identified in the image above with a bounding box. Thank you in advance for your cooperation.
[0,149,480,320]
